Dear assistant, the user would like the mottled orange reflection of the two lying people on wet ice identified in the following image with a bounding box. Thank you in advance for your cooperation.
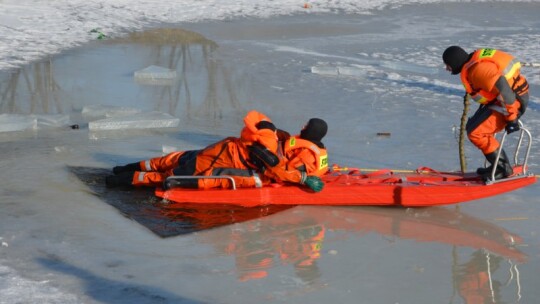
[205,218,326,284]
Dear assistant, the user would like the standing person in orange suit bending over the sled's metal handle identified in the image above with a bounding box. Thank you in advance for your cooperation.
[442,46,529,179]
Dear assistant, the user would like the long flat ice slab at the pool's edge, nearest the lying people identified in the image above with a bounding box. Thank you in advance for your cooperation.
[88,111,180,131]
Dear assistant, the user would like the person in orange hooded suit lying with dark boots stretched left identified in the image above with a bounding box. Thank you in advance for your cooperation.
[106,111,323,192]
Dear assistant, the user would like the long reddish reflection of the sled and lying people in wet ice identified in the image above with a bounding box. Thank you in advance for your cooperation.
[181,205,527,294]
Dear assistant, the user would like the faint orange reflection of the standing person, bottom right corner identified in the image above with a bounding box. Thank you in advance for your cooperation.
[454,250,501,304]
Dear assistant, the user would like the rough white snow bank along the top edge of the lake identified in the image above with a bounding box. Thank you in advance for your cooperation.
[0,0,538,69]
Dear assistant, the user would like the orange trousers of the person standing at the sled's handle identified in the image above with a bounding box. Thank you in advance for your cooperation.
[467,111,506,155]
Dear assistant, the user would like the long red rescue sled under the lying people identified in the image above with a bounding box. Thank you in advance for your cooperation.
[156,166,536,207]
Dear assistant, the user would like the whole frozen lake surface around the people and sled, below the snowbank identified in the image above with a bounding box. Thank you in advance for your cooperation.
[0,2,540,304]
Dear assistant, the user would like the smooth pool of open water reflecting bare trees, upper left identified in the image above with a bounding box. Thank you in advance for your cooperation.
[0,28,245,126]
